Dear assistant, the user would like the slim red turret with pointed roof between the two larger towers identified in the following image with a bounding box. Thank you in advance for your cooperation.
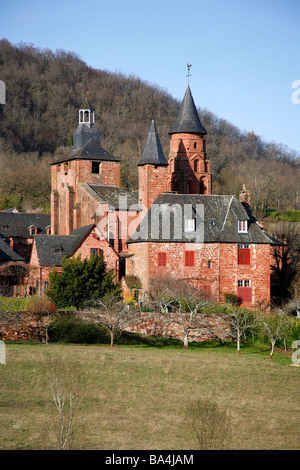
[138,120,168,210]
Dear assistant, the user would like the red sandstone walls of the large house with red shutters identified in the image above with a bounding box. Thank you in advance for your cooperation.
[126,242,270,307]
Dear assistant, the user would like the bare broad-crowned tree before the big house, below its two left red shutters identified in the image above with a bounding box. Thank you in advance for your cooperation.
[151,277,208,349]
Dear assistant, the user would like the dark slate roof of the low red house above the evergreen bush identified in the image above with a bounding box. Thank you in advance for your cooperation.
[34,224,95,266]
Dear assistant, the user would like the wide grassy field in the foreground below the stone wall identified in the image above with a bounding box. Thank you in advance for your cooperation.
[0,343,300,450]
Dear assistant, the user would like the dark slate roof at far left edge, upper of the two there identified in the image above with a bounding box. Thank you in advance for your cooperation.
[0,212,51,238]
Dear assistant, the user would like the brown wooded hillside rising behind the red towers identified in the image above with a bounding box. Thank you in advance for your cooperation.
[0,39,300,215]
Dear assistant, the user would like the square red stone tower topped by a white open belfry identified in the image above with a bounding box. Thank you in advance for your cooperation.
[51,95,121,235]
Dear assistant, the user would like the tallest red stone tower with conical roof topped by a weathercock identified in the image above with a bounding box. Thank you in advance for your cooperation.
[168,85,212,194]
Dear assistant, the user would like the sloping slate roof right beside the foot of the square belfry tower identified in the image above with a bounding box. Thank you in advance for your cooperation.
[80,183,142,211]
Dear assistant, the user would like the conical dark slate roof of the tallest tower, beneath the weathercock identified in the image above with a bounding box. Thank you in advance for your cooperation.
[169,86,207,134]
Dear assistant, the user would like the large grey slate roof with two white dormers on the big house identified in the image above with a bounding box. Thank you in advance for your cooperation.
[127,193,274,244]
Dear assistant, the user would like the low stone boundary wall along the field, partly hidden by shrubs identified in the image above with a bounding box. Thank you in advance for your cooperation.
[0,311,232,342]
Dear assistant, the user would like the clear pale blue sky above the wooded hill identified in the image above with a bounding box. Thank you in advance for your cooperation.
[0,0,300,154]
